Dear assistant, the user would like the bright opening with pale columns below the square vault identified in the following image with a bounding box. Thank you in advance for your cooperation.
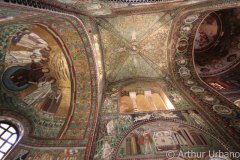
[118,82,175,113]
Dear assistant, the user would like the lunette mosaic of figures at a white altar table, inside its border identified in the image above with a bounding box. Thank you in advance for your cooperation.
[116,121,224,159]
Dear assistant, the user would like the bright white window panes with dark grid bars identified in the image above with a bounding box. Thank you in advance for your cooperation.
[0,122,19,160]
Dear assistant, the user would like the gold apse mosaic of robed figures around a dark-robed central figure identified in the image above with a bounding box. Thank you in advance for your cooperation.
[2,25,71,116]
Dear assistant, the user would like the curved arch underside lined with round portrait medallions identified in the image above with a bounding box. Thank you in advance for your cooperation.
[168,2,240,149]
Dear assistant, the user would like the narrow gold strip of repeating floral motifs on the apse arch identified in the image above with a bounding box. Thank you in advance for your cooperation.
[48,18,91,139]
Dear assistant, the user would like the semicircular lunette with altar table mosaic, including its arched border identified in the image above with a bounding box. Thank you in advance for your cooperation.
[111,119,228,159]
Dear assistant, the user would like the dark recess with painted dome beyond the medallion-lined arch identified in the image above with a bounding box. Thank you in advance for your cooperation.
[194,8,240,109]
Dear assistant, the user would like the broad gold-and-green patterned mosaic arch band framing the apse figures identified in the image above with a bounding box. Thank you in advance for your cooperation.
[0,8,98,156]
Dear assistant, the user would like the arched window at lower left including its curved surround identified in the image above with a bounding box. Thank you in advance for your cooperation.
[0,116,24,159]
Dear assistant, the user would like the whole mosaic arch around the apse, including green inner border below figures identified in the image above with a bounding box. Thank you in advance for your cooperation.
[0,6,99,160]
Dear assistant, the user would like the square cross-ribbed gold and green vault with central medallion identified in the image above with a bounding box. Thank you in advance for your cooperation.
[96,11,176,82]
